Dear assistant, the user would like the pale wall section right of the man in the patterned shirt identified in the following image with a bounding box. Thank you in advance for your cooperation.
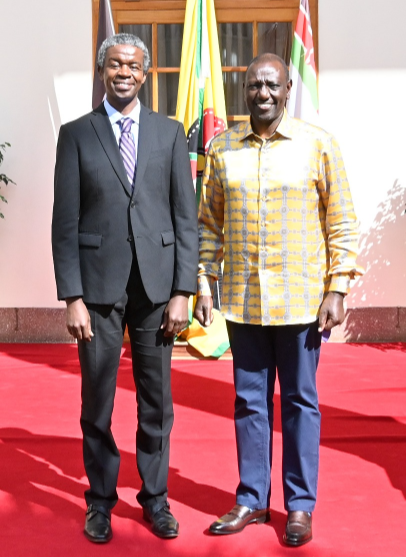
[319,0,406,307]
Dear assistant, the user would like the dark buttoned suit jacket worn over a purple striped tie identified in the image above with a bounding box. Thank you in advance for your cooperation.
[52,105,198,304]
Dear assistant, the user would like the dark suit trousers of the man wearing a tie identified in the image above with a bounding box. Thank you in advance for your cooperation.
[78,257,173,512]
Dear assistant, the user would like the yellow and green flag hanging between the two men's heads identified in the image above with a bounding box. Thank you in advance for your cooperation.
[176,0,227,204]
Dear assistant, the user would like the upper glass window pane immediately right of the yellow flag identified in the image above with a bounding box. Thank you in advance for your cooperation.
[218,23,253,66]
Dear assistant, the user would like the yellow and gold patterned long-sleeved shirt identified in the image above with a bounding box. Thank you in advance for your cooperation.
[198,111,362,325]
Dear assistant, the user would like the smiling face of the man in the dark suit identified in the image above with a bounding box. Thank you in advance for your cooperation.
[99,44,147,112]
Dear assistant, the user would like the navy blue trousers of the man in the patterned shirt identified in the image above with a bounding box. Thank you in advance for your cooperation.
[227,321,321,512]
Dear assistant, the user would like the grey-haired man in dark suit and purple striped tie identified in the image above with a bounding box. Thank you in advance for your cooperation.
[52,34,198,542]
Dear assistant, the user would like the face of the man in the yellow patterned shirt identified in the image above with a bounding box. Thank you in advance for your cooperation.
[244,59,292,129]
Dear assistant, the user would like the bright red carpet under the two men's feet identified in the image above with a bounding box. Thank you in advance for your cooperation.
[0,344,406,557]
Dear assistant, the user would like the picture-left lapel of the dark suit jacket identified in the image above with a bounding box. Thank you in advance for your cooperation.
[90,104,131,196]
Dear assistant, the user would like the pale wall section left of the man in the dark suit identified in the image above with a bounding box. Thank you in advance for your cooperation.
[0,0,92,307]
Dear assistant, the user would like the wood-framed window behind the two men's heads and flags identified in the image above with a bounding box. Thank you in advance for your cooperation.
[93,0,318,125]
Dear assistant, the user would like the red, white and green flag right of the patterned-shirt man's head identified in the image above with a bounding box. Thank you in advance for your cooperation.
[288,0,319,124]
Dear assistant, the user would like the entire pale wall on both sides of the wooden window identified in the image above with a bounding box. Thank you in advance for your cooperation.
[0,0,406,307]
